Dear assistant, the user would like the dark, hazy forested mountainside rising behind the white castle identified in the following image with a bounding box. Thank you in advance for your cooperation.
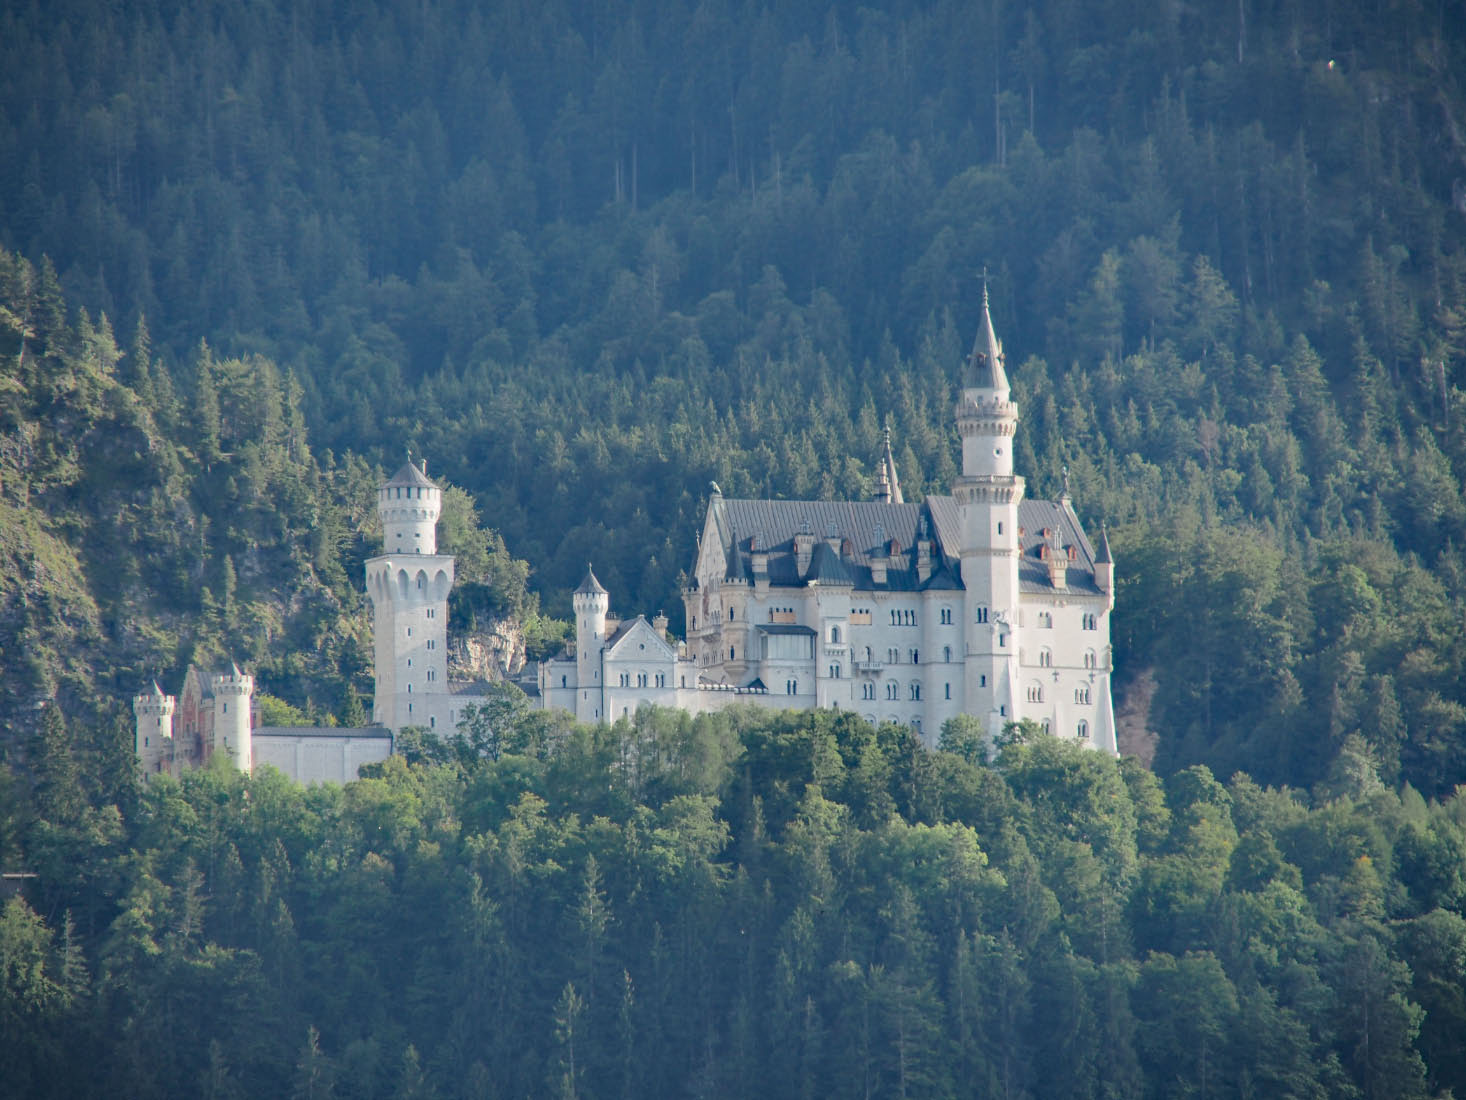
[0,0,1466,793]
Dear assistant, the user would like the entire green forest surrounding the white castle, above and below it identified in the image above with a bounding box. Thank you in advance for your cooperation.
[0,0,1466,1100]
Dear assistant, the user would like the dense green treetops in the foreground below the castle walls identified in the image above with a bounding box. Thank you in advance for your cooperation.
[0,706,1466,1100]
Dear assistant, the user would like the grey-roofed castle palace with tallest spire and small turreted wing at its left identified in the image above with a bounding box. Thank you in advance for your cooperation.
[538,290,1116,754]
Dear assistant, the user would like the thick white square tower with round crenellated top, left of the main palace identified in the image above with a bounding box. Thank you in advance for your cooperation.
[367,459,453,732]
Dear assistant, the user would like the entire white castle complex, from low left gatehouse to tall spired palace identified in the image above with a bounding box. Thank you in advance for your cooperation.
[133,290,1116,782]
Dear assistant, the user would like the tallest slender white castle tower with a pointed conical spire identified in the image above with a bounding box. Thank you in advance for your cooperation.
[953,276,1023,736]
